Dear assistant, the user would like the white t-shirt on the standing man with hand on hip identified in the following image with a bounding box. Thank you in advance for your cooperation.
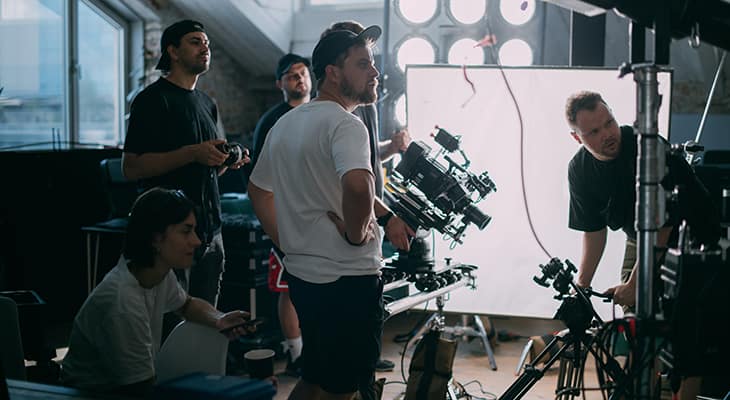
[250,101,382,283]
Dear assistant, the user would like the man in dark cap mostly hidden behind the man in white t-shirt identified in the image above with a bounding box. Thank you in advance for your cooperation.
[251,53,312,376]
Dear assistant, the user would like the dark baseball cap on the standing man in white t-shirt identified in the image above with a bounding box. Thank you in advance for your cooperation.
[312,25,383,80]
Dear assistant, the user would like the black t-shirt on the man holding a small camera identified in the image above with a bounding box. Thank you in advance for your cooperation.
[124,78,221,242]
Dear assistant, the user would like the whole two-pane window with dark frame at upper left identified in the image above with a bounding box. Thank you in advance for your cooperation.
[0,0,126,150]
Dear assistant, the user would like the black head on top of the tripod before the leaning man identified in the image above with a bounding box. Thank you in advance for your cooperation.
[532,257,608,336]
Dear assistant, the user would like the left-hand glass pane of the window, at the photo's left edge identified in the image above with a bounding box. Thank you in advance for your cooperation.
[0,0,67,149]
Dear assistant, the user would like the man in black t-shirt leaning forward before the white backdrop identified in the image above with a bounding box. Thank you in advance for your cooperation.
[565,91,719,306]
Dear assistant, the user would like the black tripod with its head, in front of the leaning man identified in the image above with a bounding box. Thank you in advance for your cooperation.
[499,258,628,400]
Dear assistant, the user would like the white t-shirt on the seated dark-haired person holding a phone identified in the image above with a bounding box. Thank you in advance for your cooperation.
[61,257,187,390]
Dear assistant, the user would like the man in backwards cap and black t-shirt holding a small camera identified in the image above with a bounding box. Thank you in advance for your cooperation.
[122,20,249,306]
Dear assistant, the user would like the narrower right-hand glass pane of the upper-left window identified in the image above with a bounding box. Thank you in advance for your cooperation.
[78,1,124,146]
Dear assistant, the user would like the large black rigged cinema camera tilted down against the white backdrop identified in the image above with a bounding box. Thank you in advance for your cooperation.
[386,126,497,245]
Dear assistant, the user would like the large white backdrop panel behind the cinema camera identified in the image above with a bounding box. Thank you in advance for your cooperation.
[406,66,671,318]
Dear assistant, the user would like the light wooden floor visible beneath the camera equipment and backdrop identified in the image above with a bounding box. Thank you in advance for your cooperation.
[266,312,601,400]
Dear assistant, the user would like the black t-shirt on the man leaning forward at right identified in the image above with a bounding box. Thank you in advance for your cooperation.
[568,126,720,243]
